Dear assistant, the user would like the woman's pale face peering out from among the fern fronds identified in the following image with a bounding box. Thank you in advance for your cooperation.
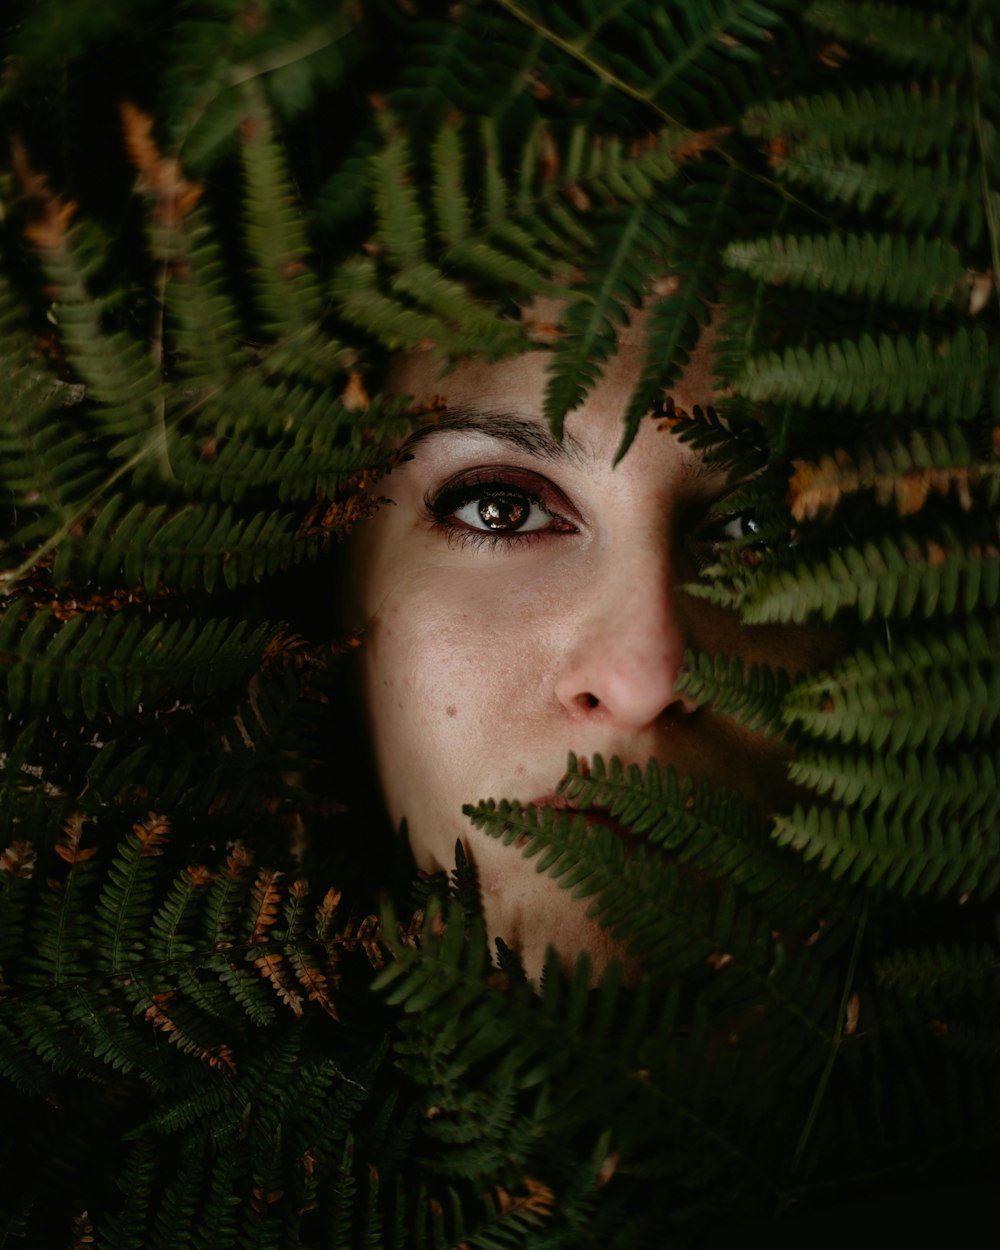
[351,320,825,976]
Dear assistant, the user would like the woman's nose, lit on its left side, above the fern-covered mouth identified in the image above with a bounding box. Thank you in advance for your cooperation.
[556,560,698,729]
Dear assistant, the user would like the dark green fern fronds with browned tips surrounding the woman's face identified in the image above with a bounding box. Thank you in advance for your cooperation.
[0,0,1000,1250]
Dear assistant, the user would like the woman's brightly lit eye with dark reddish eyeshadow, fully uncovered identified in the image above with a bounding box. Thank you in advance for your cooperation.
[425,466,576,546]
